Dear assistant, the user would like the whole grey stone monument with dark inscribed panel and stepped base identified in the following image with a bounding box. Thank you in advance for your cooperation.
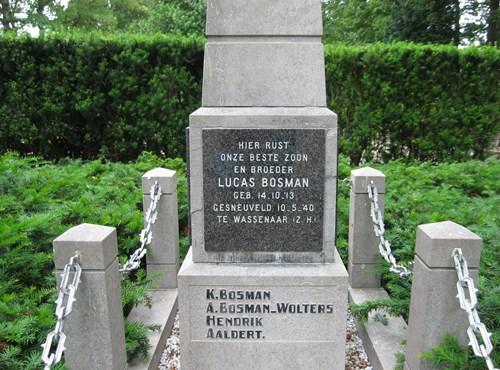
[178,0,347,370]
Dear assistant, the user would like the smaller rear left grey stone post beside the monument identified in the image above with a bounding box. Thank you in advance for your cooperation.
[142,168,179,289]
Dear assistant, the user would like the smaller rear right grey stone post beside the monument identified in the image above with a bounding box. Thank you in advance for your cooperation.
[348,167,385,288]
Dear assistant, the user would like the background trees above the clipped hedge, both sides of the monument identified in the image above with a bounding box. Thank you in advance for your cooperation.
[0,0,500,46]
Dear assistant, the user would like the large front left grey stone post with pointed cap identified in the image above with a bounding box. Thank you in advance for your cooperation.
[53,224,127,370]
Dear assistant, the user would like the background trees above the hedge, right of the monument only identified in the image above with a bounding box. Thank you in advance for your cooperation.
[323,0,500,46]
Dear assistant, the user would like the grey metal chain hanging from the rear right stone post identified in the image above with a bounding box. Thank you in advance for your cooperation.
[368,181,412,279]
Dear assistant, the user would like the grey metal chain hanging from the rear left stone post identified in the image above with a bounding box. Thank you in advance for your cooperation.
[120,181,161,275]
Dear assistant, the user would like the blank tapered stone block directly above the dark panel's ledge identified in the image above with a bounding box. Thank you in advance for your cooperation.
[202,40,326,107]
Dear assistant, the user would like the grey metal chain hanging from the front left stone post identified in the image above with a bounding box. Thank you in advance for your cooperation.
[42,255,82,370]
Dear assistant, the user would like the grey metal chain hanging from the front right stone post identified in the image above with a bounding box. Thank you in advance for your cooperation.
[453,248,495,370]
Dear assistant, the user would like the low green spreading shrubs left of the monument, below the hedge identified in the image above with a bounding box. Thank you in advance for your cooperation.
[0,153,187,369]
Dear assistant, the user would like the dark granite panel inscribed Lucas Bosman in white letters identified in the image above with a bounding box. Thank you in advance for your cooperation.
[202,129,325,252]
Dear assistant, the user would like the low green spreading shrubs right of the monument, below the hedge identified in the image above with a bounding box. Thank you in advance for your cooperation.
[338,158,500,370]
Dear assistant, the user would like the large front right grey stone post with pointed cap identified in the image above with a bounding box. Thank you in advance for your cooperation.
[405,221,481,370]
